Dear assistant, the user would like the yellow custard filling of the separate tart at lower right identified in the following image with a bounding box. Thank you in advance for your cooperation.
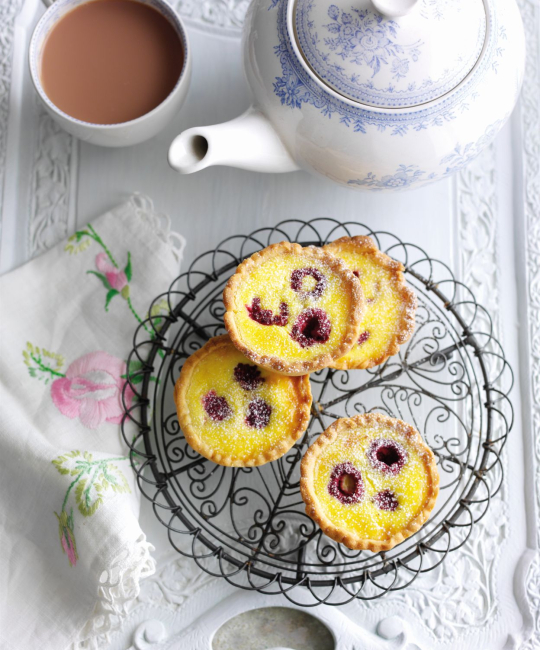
[313,426,430,541]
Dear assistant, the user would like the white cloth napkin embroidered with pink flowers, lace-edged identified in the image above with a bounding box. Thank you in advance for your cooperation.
[0,196,183,650]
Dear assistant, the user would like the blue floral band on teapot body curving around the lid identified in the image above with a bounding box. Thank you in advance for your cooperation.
[268,0,496,136]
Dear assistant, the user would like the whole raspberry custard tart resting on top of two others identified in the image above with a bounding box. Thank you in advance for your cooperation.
[223,242,364,375]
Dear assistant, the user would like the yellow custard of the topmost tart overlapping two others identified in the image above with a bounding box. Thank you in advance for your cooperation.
[235,253,352,361]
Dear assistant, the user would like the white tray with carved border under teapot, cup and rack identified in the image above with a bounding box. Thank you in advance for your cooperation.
[0,0,540,650]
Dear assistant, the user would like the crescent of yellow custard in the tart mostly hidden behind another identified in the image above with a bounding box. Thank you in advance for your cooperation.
[332,249,405,365]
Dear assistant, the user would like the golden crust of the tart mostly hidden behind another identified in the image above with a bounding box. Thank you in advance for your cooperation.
[324,235,418,370]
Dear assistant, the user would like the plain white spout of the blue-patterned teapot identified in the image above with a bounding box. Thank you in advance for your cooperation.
[169,107,300,174]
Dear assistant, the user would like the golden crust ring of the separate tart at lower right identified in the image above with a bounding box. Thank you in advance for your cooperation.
[300,413,439,553]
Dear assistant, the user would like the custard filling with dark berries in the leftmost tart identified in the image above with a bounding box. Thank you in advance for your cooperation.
[186,343,310,459]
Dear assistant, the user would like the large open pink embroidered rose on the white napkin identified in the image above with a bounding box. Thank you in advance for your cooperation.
[51,352,133,429]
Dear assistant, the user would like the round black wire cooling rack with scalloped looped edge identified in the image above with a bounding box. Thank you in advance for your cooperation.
[122,219,513,606]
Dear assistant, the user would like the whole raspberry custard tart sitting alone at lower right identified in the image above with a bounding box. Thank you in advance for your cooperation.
[300,413,439,553]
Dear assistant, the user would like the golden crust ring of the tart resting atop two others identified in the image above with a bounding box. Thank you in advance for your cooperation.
[223,242,364,376]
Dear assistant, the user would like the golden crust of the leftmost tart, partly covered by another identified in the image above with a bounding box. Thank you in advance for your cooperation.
[174,334,312,467]
